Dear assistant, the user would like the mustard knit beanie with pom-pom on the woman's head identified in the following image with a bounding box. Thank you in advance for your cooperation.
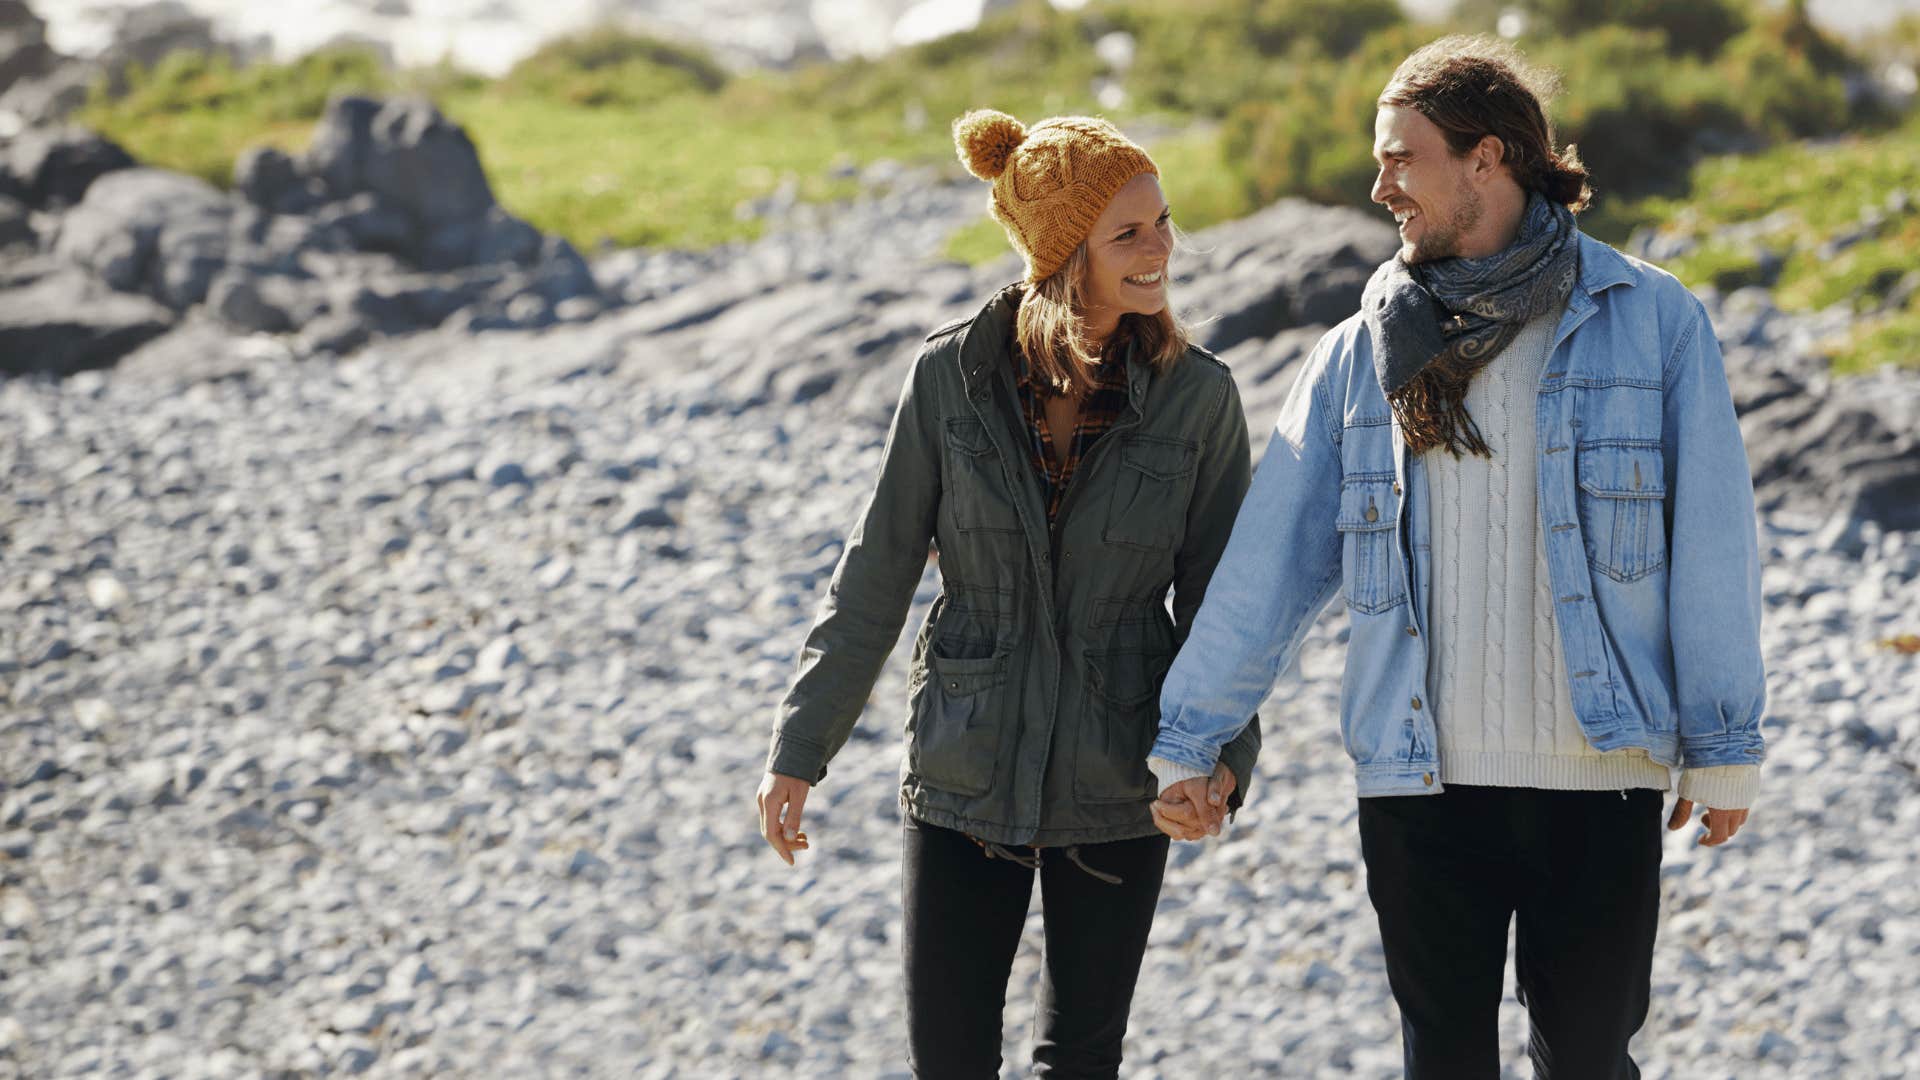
[954,110,1160,284]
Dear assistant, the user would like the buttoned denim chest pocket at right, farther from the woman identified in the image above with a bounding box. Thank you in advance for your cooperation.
[1574,444,1667,582]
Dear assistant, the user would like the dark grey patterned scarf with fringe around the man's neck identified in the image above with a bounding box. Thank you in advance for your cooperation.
[1361,192,1580,457]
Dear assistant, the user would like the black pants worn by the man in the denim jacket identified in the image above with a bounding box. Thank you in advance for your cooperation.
[1359,786,1661,1080]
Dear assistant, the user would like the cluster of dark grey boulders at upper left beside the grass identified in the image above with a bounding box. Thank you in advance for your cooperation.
[0,96,607,359]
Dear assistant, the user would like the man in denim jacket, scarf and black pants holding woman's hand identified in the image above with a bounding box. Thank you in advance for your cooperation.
[1150,38,1764,1078]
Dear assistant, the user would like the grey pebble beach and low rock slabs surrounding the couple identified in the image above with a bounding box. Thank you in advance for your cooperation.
[0,159,1920,1080]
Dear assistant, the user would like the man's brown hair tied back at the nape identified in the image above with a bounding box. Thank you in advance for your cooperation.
[1377,35,1594,213]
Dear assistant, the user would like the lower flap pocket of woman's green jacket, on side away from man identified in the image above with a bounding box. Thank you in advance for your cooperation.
[906,651,1008,796]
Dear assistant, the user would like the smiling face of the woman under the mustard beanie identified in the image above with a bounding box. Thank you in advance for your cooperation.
[1081,173,1173,340]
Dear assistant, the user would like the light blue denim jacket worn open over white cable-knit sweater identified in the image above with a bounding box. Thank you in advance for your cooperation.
[1152,234,1766,798]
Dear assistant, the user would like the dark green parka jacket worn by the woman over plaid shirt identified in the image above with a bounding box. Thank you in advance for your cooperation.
[768,286,1260,847]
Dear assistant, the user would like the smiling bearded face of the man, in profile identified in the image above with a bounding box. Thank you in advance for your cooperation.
[1373,106,1480,263]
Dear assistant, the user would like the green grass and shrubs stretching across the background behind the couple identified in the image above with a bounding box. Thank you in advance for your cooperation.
[63,0,1920,369]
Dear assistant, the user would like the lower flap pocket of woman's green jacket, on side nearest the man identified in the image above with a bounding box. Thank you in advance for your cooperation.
[1073,651,1173,803]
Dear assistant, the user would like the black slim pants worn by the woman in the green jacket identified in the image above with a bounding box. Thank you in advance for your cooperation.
[902,819,1167,1080]
